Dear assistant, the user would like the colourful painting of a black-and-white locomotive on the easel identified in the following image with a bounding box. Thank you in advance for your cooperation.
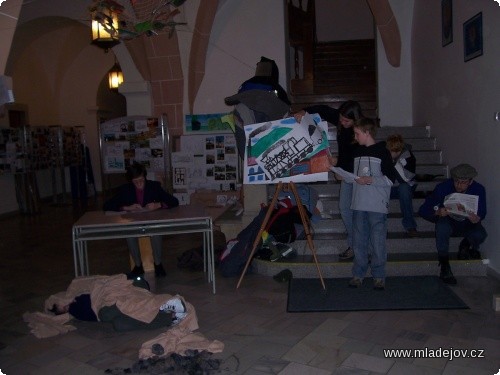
[243,114,330,184]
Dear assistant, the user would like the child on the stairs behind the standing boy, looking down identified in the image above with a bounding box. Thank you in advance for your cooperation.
[386,134,418,237]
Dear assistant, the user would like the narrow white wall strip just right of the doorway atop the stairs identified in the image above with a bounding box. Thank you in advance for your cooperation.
[377,0,415,126]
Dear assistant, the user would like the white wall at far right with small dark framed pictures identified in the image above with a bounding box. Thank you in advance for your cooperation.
[413,0,500,272]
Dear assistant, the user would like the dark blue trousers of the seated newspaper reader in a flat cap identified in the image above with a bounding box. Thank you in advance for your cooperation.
[436,216,488,257]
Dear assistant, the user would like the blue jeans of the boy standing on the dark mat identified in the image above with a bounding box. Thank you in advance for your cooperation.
[352,210,387,279]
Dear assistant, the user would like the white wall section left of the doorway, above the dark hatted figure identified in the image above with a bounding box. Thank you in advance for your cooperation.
[194,0,287,113]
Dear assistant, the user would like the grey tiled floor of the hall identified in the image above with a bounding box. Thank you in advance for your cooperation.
[0,205,500,375]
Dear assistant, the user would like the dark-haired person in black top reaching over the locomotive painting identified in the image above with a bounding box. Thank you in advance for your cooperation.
[294,100,364,259]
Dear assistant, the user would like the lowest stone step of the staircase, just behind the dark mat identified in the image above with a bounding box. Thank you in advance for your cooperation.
[252,254,488,280]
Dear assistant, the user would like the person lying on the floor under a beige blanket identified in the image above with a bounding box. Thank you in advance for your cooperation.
[41,274,198,331]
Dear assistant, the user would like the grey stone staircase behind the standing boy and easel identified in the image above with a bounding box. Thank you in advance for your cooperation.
[252,126,487,278]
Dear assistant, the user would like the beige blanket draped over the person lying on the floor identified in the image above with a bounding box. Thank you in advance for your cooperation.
[23,275,224,359]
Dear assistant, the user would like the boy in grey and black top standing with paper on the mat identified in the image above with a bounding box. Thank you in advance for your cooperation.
[349,118,396,290]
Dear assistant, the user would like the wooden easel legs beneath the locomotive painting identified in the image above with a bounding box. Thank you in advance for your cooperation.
[236,181,326,289]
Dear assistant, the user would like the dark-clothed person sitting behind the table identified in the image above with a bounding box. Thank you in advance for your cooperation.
[103,163,179,277]
